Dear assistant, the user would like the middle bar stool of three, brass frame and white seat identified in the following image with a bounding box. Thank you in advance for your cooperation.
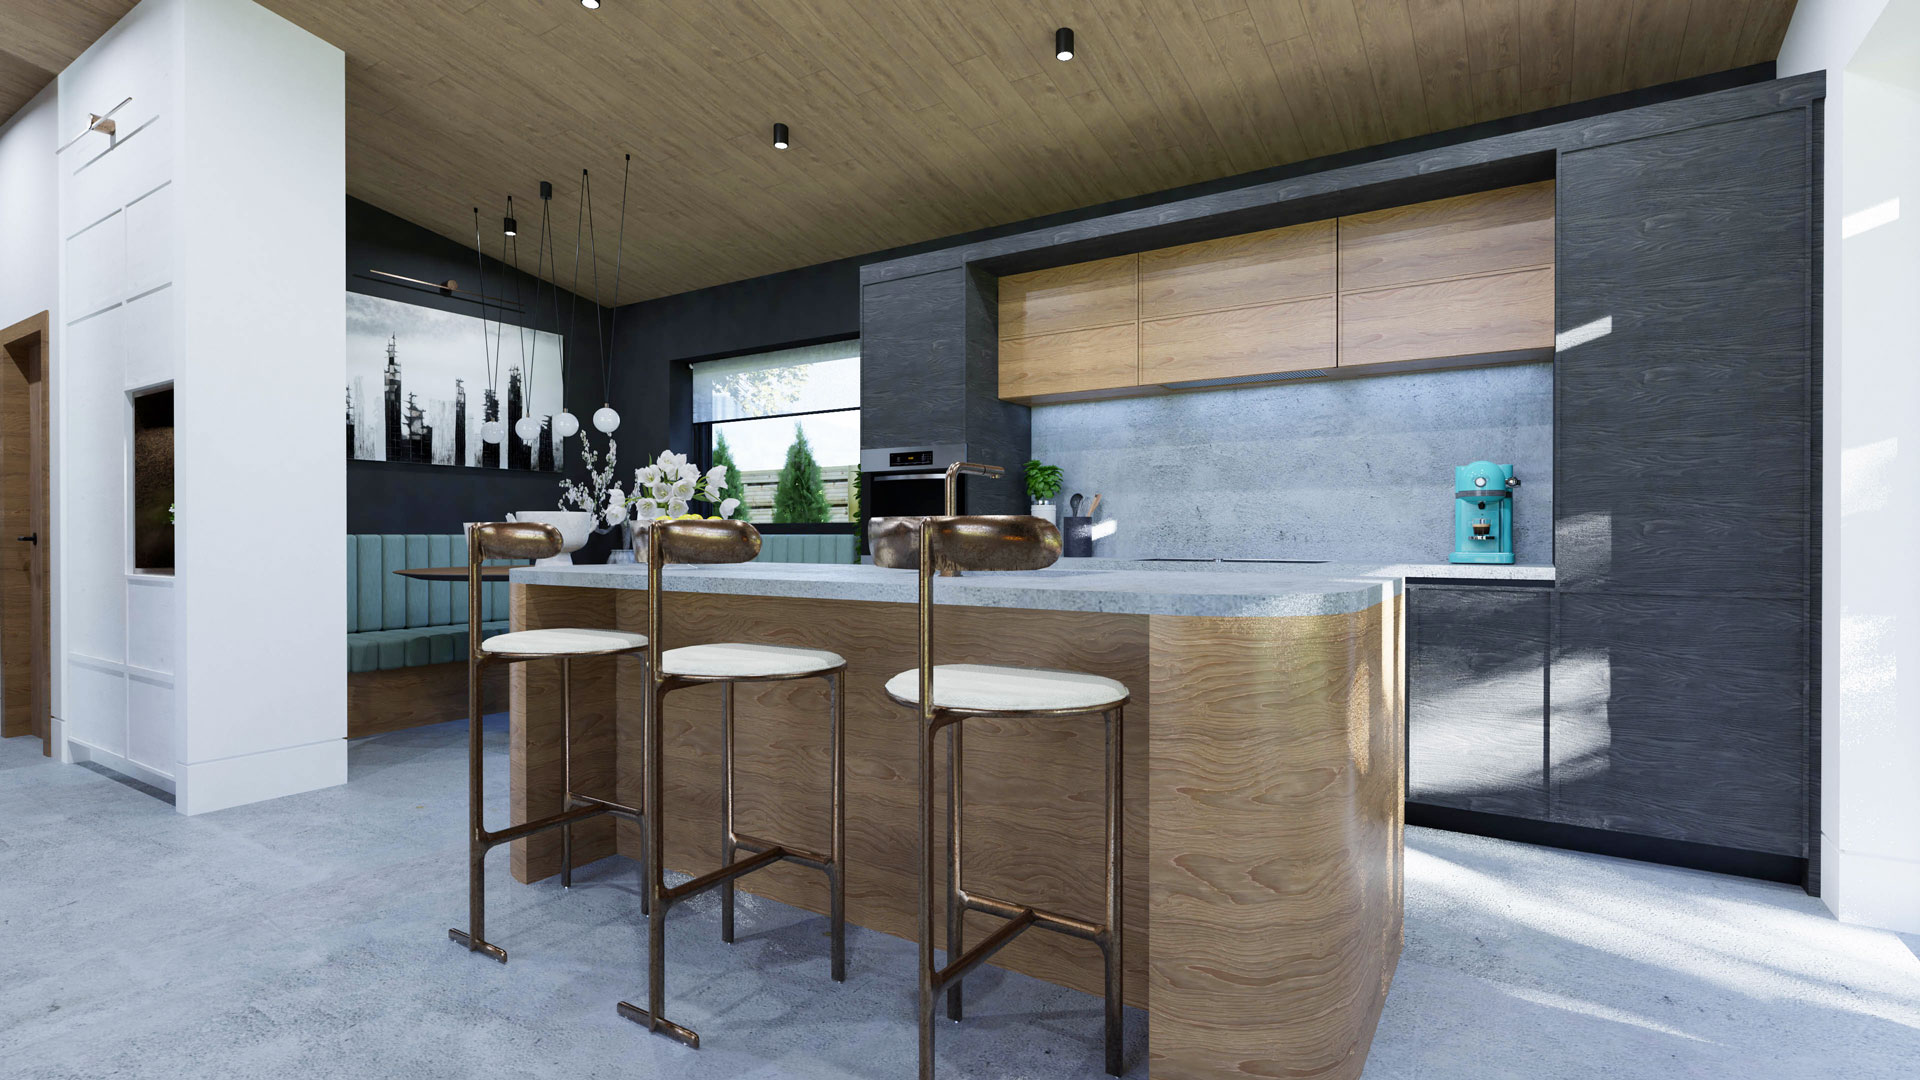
[618,519,847,1049]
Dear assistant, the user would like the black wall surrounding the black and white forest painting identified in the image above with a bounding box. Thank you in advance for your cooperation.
[346,198,612,532]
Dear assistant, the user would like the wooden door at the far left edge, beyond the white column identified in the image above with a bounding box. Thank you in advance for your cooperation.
[0,311,54,755]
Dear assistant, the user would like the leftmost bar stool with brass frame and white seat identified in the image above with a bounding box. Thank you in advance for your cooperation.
[447,521,647,963]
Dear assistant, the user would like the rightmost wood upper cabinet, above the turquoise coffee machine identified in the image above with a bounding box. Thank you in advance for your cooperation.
[1340,181,1553,367]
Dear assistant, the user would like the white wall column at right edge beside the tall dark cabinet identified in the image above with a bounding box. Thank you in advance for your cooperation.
[1780,0,1920,932]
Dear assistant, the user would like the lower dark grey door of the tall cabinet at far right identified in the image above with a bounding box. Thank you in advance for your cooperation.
[1549,592,1809,857]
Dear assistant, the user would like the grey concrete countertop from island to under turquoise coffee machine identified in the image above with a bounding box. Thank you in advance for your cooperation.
[509,559,1553,619]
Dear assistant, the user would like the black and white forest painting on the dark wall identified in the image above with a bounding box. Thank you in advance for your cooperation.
[348,292,564,473]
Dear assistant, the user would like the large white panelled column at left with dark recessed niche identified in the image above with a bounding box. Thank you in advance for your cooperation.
[56,0,346,813]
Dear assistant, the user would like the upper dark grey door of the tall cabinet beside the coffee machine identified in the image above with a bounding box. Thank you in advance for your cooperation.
[1553,110,1814,596]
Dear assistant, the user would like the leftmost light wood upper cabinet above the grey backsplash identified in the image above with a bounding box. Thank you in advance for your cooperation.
[1000,256,1140,402]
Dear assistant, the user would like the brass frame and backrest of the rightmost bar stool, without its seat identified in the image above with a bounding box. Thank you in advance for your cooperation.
[872,515,1129,1080]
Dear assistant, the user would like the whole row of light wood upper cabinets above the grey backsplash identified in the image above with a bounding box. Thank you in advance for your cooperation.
[1000,181,1553,402]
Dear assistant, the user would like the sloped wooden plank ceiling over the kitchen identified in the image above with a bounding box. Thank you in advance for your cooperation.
[0,0,1793,304]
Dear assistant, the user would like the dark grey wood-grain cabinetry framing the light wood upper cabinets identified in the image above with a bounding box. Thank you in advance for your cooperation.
[860,75,1824,892]
